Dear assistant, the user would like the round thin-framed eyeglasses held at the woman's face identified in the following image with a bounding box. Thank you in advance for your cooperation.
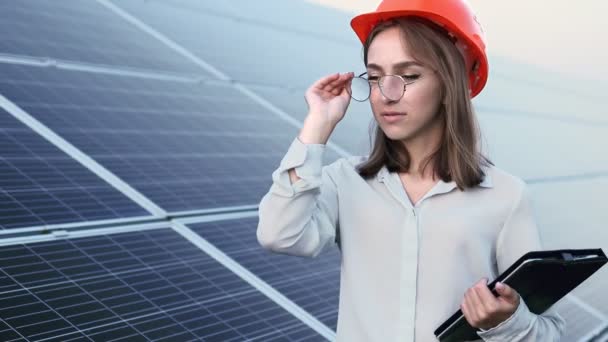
[348,72,420,102]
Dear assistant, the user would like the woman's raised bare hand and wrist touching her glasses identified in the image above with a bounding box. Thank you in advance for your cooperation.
[298,72,354,144]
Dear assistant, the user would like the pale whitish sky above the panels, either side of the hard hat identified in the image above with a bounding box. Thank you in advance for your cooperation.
[308,0,608,81]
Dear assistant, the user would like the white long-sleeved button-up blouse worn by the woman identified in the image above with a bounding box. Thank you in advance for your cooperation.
[257,138,564,342]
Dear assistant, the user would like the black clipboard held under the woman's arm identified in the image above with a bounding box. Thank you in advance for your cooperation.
[435,248,608,342]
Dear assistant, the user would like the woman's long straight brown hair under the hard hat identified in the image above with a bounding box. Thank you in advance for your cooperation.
[358,17,492,190]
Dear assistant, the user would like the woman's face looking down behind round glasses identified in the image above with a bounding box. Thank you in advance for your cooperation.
[367,27,442,143]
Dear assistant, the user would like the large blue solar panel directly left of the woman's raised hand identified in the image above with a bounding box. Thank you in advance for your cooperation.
[0,64,342,211]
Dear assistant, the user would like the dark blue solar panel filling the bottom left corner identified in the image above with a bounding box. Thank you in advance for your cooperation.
[0,229,323,342]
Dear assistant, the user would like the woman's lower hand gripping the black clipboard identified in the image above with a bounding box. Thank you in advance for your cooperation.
[460,278,520,330]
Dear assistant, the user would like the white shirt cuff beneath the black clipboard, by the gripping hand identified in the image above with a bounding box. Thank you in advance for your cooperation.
[477,298,536,341]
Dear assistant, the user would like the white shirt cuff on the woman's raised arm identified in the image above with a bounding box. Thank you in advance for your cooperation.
[270,137,325,197]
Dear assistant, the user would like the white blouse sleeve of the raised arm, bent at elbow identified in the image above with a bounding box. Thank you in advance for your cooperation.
[257,138,338,257]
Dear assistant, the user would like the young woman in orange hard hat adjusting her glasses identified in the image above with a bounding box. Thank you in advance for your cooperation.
[257,0,564,342]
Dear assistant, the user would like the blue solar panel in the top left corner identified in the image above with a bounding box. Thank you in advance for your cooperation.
[0,0,205,74]
